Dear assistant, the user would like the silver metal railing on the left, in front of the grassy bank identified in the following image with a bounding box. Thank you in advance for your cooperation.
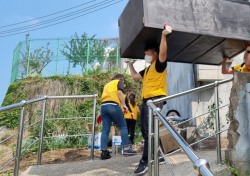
[0,94,97,176]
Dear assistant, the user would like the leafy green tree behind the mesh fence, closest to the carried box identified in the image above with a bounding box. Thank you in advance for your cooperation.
[61,33,110,73]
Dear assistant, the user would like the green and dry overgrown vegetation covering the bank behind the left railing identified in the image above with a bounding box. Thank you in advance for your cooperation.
[0,72,141,156]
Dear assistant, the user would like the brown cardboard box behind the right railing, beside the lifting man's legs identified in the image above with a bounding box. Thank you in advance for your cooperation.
[159,126,180,153]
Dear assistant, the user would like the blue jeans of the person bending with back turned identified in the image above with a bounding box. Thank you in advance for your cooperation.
[101,104,129,150]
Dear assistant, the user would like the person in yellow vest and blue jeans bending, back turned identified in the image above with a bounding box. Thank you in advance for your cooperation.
[100,74,135,160]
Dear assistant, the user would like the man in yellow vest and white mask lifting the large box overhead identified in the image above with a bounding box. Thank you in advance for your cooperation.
[126,25,172,175]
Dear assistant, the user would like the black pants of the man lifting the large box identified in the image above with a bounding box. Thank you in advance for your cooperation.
[141,101,164,162]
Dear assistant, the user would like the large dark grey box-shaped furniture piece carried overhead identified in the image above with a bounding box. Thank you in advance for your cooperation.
[118,0,250,65]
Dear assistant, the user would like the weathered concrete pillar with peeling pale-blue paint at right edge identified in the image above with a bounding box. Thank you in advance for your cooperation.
[226,72,250,175]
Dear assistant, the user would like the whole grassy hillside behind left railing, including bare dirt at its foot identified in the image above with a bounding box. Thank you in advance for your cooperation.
[0,73,141,175]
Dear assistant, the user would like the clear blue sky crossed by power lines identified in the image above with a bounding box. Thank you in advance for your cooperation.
[0,0,128,105]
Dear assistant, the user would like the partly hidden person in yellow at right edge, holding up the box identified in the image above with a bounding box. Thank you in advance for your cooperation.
[221,45,250,74]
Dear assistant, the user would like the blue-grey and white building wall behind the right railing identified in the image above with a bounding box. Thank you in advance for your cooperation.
[163,54,243,137]
